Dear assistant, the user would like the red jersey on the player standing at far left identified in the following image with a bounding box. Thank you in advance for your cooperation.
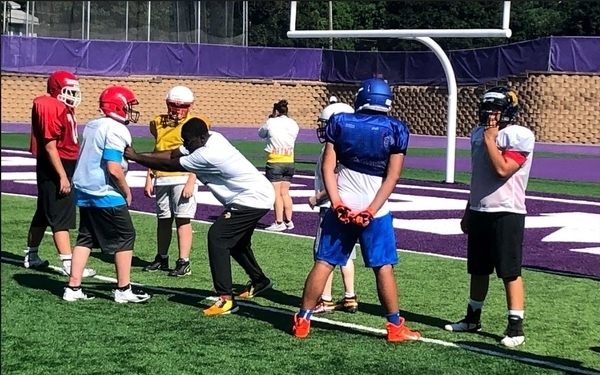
[29,95,79,160]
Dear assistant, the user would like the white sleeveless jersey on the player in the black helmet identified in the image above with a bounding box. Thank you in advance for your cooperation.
[469,125,535,214]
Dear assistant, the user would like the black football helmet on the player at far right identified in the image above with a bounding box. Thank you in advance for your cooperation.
[479,86,521,125]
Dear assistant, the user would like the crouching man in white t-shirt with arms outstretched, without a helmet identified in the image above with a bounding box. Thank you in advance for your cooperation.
[125,117,275,315]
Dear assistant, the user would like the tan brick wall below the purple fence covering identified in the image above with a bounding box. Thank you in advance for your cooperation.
[1,74,600,144]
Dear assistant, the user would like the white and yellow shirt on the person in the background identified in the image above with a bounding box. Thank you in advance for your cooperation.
[258,115,300,163]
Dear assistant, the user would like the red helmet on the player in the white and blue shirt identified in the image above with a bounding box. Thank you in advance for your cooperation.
[100,86,140,125]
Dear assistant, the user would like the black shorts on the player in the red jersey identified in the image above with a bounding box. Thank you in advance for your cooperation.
[31,159,77,232]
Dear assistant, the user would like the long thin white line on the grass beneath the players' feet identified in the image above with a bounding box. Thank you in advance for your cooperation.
[2,257,600,375]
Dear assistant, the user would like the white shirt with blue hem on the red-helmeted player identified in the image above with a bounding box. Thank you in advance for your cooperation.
[73,117,131,207]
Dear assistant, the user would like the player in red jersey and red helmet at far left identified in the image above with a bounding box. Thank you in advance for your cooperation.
[23,70,96,277]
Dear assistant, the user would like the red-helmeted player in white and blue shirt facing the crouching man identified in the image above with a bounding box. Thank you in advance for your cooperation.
[63,86,150,303]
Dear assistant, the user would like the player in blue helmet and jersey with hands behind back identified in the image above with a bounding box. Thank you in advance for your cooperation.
[293,78,421,342]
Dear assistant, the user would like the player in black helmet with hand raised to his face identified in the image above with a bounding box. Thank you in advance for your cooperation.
[445,87,535,347]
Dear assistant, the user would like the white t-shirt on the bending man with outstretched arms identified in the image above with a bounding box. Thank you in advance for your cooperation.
[179,131,275,209]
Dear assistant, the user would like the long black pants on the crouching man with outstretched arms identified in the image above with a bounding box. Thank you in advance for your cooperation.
[208,205,269,295]
